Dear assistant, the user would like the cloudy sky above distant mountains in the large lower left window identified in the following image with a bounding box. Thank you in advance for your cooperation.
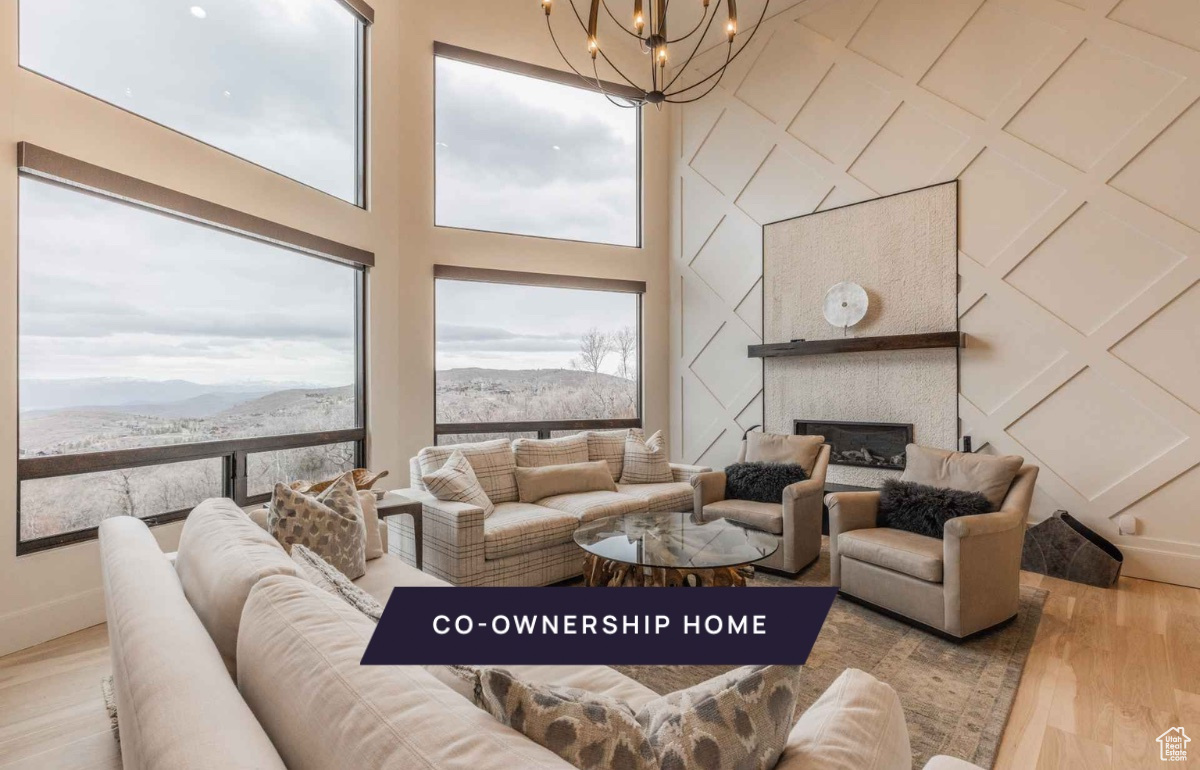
[20,178,354,386]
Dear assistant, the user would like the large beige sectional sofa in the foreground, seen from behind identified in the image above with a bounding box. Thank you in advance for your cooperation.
[100,500,972,770]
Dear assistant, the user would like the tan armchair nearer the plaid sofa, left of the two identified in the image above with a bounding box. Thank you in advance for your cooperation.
[692,444,830,575]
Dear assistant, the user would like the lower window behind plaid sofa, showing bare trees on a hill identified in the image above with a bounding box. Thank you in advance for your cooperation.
[436,266,644,444]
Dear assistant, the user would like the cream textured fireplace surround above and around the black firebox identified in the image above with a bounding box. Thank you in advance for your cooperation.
[763,182,959,486]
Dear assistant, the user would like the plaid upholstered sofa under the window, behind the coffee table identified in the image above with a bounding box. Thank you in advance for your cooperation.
[406,428,710,585]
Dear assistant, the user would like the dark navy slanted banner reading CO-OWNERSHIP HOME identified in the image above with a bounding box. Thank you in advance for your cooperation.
[362,586,838,666]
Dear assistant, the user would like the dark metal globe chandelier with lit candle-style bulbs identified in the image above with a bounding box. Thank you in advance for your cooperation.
[541,0,770,107]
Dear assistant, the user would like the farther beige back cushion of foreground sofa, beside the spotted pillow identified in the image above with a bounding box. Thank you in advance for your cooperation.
[175,499,300,674]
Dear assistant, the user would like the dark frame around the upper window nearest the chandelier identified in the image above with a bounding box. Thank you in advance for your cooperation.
[433,41,646,249]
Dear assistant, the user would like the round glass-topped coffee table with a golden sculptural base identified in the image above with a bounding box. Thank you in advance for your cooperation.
[575,513,779,585]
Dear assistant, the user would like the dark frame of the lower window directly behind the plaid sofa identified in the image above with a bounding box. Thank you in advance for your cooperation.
[433,265,646,444]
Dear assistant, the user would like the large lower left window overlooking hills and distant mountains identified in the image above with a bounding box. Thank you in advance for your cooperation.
[18,148,365,551]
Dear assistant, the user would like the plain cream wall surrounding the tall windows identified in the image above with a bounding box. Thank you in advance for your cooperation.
[0,0,668,654]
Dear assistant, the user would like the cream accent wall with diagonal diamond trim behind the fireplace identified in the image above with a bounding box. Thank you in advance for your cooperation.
[670,0,1200,585]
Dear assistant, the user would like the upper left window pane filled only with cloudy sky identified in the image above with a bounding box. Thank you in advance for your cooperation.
[20,0,365,203]
